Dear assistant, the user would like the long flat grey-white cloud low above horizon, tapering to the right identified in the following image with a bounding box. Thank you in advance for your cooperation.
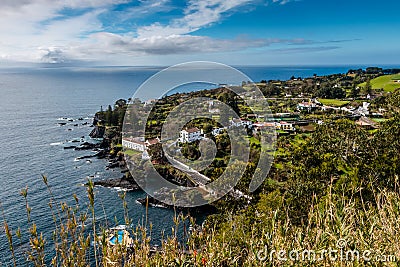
[47,32,308,62]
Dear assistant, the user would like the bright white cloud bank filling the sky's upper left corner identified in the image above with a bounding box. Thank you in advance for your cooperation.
[0,0,126,62]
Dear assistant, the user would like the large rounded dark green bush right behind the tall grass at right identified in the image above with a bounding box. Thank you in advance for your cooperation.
[287,120,374,223]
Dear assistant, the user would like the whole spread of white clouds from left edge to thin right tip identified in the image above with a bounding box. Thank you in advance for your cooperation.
[0,0,306,63]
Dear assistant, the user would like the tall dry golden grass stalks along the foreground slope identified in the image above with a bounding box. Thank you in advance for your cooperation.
[4,177,400,266]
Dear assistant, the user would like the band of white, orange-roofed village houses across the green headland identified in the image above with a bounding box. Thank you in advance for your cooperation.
[122,95,386,159]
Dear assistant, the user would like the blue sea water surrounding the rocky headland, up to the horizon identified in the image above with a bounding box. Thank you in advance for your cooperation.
[0,67,378,266]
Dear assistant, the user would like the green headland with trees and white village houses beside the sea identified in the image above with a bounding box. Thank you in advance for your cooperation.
[70,68,400,207]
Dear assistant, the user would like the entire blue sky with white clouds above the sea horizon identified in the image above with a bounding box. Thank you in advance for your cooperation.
[0,0,400,66]
